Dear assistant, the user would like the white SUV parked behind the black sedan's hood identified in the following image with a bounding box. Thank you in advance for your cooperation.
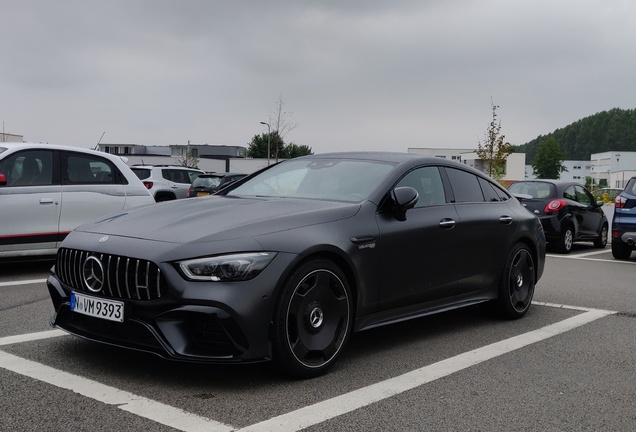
[131,165,205,202]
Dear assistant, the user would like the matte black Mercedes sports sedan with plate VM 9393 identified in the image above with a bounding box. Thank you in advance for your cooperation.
[47,153,545,377]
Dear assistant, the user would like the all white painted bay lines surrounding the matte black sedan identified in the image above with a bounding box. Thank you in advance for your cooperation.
[0,302,616,432]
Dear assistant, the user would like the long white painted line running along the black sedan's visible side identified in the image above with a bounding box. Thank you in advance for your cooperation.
[239,309,615,432]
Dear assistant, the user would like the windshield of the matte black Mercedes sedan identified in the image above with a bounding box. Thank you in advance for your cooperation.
[227,158,394,202]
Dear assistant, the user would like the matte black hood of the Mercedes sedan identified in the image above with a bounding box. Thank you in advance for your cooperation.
[75,196,360,243]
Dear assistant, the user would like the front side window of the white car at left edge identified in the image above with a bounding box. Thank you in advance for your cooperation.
[0,150,53,187]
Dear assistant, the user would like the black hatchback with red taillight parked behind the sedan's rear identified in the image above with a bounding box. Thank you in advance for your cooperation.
[508,180,609,253]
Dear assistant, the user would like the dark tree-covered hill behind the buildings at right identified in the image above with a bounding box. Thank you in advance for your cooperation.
[514,108,636,164]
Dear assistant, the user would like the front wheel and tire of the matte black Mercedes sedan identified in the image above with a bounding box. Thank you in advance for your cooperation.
[272,259,353,378]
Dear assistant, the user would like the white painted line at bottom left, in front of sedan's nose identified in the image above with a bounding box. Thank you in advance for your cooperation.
[0,351,235,432]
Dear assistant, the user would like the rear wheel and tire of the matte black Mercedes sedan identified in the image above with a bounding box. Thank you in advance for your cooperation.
[490,243,535,319]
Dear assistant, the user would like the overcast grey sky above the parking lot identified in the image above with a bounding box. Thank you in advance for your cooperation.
[0,0,636,153]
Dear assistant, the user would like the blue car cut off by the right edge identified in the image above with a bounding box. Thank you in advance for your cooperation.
[612,177,636,259]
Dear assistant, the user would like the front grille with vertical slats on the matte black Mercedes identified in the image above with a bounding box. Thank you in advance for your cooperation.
[55,248,165,300]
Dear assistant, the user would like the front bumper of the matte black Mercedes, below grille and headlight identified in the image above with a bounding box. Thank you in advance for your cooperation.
[47,248,293,363]
